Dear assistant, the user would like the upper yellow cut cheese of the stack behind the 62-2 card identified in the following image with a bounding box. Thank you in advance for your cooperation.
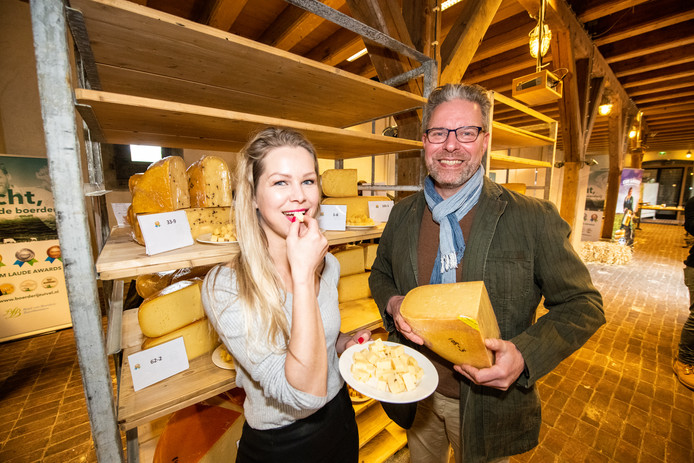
[137,278,205,338]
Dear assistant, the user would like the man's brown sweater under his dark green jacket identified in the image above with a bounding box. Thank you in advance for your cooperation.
[417,206,477,399]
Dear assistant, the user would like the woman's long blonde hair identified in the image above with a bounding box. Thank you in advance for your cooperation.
[232,127,320,352]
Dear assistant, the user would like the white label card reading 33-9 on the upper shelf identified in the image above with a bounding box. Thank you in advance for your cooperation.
[137,210,194,256]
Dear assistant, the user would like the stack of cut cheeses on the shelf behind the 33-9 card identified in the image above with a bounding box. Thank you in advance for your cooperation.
[127,155,239,246]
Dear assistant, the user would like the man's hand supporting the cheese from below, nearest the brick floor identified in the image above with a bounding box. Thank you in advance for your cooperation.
[453,339,525,391]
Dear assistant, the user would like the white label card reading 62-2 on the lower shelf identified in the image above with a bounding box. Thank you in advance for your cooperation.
[128,337,189,391]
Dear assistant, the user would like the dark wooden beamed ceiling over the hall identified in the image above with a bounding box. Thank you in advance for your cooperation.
[115,0,694,155]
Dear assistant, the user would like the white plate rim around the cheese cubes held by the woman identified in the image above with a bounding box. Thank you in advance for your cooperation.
[339,341,439,404]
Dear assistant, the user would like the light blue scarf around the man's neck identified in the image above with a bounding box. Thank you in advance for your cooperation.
[424,166,484,285]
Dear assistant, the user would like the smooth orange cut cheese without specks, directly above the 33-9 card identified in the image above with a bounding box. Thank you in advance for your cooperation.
[129,156,190,214]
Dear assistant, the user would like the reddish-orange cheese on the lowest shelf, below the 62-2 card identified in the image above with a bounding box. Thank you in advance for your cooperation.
[152,397,245,463]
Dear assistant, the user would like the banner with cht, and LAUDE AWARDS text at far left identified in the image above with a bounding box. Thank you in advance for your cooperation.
[0,155,72,342]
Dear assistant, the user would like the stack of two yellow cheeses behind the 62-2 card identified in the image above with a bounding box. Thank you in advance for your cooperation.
[137,278,219,360]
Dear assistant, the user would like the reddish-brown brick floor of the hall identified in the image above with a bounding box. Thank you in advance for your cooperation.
[0,223,694,463]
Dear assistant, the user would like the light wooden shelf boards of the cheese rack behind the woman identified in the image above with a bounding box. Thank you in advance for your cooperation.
[75,0,426,462]
